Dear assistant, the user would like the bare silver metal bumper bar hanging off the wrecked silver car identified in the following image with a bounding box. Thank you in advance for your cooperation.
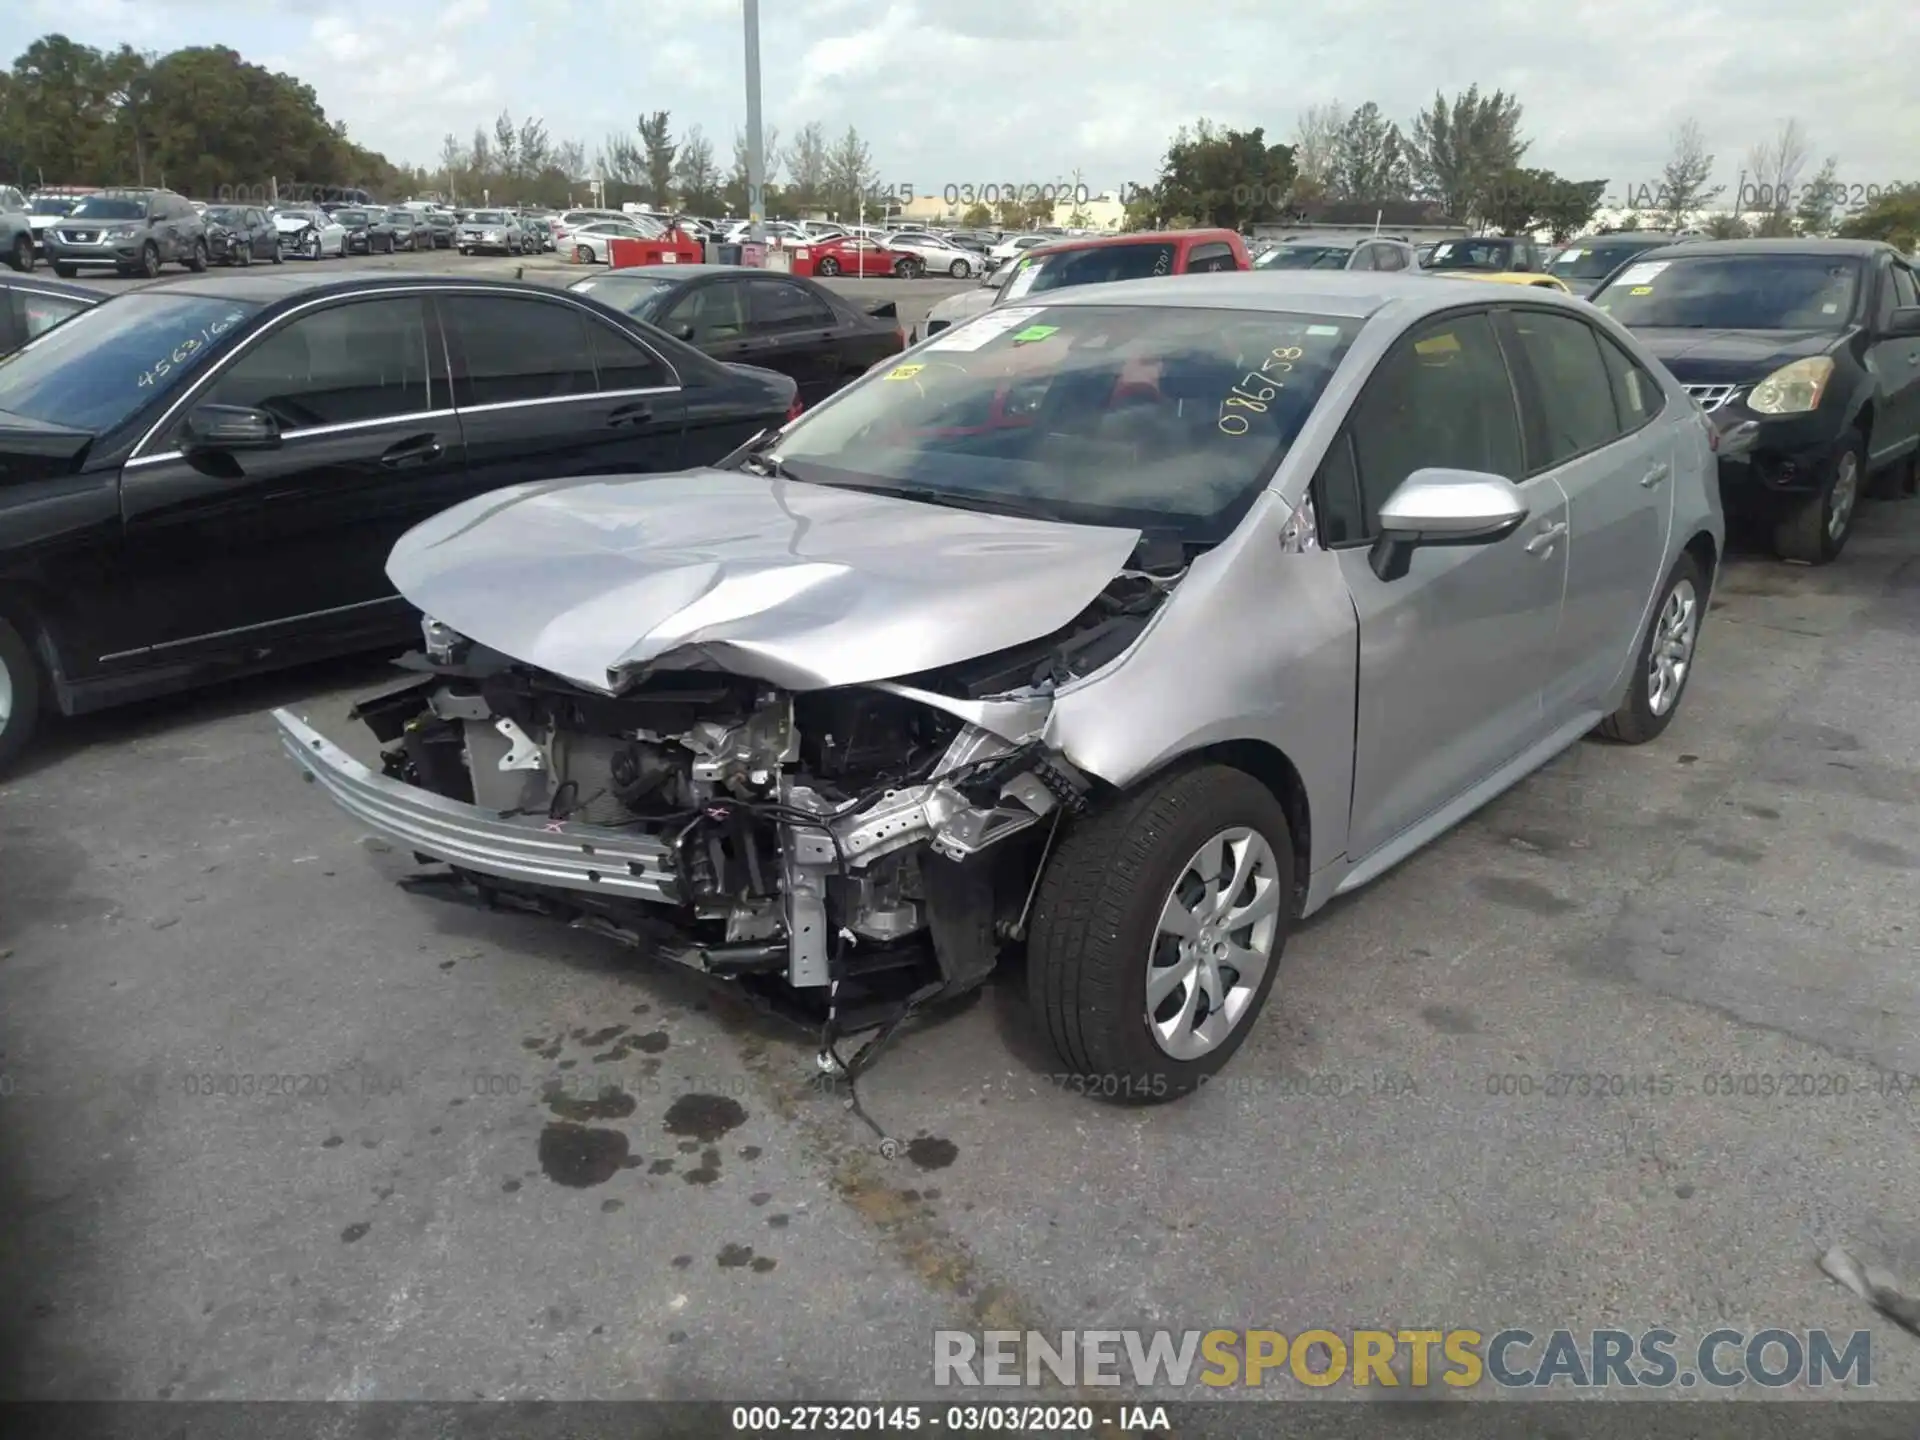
[273,710,680,904]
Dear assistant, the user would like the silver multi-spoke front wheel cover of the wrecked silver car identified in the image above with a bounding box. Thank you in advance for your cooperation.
[1146,826,1286,1060]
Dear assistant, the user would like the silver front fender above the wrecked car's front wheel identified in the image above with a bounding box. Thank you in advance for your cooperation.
[1046,493,1359,870]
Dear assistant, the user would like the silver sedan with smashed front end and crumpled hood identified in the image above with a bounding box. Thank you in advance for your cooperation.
[276,273,1722,1102]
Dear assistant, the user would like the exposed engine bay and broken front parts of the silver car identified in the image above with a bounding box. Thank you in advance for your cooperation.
[334,545,1185,1033]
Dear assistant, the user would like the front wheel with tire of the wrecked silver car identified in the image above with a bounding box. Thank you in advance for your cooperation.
[1027,764,1294,1104]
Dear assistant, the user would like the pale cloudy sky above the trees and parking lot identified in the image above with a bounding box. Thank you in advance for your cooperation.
[11,0,1920,205]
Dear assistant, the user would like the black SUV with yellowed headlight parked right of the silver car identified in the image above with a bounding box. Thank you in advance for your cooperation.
[1592,240,1920,564]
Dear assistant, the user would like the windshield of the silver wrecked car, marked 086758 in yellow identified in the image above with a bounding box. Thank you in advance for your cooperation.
[778,305,1361,543]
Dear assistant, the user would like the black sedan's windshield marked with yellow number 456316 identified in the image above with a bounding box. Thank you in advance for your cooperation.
[0,290,259,434]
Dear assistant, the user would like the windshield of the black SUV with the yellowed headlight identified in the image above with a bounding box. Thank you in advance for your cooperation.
[1594,253,1860,330]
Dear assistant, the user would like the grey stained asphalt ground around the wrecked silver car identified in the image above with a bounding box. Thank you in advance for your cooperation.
[0,391,1920,1400]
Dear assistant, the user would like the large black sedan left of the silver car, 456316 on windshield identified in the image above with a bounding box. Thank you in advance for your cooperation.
[0,267,799,764]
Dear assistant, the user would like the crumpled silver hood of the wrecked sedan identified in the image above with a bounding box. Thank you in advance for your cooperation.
[386,470,1140,693]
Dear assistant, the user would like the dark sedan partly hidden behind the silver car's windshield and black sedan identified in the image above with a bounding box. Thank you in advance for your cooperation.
[570,265,906,405]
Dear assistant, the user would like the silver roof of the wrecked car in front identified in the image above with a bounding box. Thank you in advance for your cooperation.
[1014,271,1590,321]
